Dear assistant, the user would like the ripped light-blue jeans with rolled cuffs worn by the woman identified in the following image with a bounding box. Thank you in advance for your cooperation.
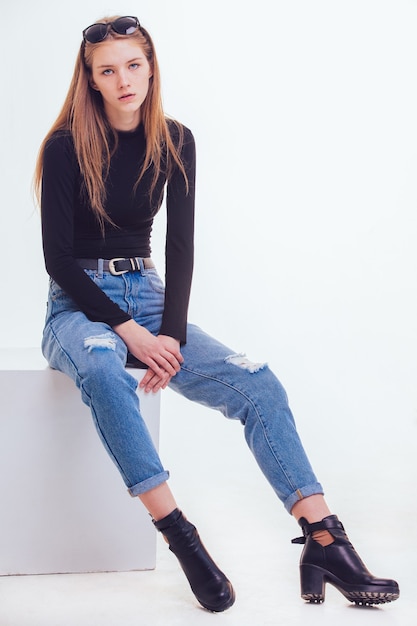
[42,269,323,512]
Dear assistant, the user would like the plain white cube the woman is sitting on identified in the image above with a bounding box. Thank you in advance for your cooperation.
[0,349,160,575]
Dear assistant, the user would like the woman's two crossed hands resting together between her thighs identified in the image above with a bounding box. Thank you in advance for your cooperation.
[113,320,184,392]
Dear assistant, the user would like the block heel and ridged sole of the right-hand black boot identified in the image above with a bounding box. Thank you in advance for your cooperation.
[300,565,400,606]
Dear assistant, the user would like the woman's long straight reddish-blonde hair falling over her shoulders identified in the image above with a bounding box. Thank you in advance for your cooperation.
[34,16,188,229]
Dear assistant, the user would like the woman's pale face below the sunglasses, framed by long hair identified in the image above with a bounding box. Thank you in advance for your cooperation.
[91,38,152,130]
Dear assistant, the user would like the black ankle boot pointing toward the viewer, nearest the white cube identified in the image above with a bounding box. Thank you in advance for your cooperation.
[153,509,235,612]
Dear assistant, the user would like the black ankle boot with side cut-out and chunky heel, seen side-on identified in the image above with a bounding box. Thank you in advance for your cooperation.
[292,515,400,605]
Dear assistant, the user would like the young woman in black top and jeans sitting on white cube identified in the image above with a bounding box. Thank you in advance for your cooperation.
[36,16,399,611]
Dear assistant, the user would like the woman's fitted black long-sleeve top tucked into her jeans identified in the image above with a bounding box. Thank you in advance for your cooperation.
[41,124,195,343]
